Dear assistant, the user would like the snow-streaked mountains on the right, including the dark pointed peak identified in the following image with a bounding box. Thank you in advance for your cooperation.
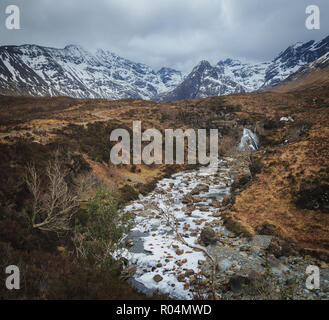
[155,36,329,101]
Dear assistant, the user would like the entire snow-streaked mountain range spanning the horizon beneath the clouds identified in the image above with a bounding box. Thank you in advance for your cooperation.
[0,36,329,101]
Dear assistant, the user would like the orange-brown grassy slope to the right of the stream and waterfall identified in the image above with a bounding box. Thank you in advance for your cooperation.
[224,88,329,259]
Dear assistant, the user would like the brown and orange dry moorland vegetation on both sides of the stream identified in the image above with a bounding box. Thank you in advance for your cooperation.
[0,79,329,299]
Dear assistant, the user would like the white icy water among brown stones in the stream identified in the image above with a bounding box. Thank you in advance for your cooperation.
[115,159,232,299]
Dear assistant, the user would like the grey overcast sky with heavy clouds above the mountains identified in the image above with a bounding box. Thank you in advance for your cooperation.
[0,0,329,72]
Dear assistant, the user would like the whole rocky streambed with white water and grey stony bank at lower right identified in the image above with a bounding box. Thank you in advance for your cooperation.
[116,159,329,299]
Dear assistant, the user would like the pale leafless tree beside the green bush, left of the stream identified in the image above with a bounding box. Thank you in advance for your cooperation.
[25,157,78,233]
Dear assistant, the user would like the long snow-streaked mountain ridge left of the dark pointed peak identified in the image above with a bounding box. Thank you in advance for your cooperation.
[0,45,183,99]
